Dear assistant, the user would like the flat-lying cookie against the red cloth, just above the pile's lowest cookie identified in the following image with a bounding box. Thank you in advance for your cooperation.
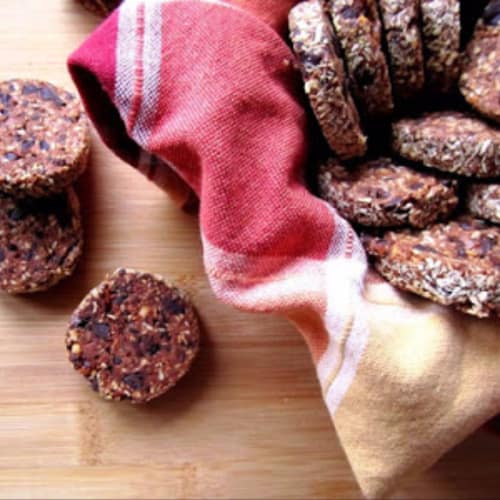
[319,158,458,227]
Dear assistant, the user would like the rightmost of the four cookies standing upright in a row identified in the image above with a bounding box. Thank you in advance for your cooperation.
[420,0,460,93]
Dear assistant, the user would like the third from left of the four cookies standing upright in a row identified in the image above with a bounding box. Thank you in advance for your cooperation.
[379,0,425,102]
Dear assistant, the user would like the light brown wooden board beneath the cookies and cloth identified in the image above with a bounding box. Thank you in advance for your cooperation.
[0,0,500,499]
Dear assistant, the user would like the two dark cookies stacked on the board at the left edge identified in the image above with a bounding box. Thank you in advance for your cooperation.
[0,80,90,293]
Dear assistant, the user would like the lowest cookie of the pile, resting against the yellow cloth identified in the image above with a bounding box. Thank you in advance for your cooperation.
[362,217,500,317]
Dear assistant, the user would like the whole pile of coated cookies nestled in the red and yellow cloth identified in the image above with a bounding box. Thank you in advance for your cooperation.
[289,0,500,317]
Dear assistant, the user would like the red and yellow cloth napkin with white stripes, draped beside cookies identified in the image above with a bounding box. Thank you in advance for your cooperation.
[69,0,500,498]
